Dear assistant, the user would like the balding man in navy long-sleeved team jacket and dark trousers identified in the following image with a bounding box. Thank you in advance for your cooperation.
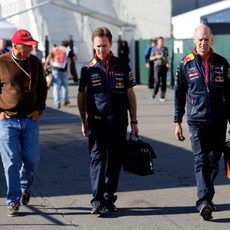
[174,25,230,220]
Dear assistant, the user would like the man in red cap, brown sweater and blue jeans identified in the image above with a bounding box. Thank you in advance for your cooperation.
[0,29,47,216]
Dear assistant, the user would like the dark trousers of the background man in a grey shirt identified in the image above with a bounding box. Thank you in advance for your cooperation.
[153,65,168,98]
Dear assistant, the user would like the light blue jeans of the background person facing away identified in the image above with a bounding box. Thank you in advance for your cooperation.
[52,69,69,105]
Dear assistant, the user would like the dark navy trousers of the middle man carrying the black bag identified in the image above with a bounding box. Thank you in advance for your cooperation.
[89,120,127,208]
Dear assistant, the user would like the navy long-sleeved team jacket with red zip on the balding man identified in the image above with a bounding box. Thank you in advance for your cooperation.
[174,49,230,124]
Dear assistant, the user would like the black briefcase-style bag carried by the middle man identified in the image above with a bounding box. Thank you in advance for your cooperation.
[123,134,156,176]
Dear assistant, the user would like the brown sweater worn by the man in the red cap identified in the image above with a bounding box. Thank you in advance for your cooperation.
[0,52,47,117]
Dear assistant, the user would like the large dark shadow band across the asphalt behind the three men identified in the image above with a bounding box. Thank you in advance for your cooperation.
[0,108,228,198]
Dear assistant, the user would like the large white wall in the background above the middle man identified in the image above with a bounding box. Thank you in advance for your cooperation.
[0,0,171,68]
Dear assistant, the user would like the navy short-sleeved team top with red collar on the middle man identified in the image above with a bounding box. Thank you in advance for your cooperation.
[79,55,136,122]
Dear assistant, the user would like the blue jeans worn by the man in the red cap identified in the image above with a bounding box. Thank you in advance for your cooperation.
[0,118,40,205]
